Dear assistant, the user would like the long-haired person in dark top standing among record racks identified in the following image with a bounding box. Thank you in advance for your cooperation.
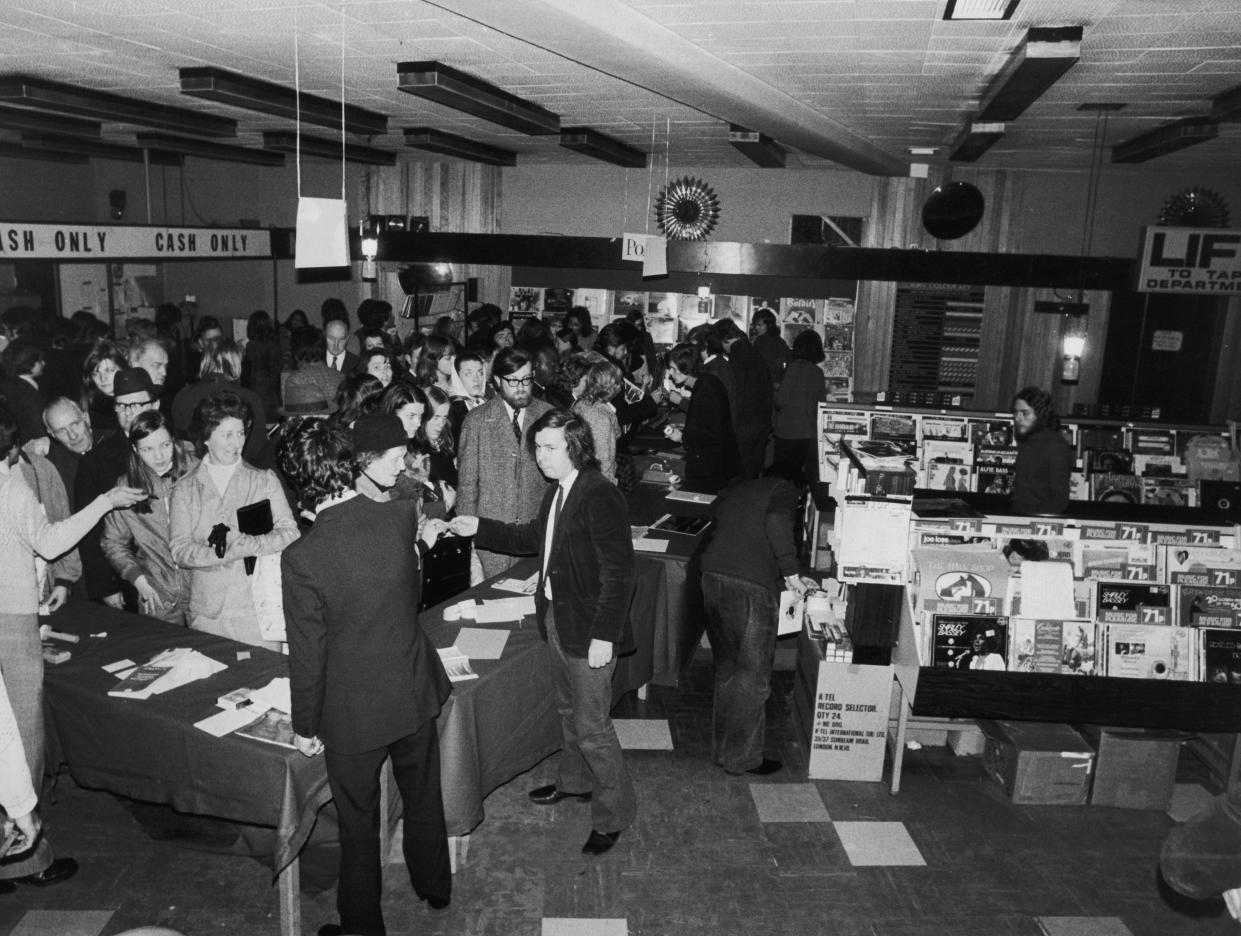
[1013,387,1073,514]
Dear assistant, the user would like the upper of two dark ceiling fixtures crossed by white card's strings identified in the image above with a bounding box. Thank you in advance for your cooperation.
[180,67,387,137]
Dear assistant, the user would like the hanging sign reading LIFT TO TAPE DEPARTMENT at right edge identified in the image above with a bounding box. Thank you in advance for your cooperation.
[1137,227,1241,295]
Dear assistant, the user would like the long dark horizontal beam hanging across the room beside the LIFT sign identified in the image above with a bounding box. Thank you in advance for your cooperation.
[369,232,1134,289]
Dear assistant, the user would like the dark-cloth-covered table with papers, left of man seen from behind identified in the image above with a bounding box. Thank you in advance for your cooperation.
[43,601,331,934]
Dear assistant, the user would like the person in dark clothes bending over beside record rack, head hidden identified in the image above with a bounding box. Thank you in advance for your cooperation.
[702,478,815,776]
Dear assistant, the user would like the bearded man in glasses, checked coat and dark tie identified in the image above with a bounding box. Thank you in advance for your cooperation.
[457,348,551,578]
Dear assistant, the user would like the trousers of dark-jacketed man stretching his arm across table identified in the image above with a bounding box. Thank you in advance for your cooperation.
[545,608,637,832]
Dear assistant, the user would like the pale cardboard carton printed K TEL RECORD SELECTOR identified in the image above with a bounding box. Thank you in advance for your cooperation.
[809,663,892,781]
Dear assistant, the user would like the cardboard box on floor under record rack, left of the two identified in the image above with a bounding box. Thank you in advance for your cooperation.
[978,720,1095,806]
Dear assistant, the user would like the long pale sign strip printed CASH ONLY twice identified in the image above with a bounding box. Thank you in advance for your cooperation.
[0,221,272,262]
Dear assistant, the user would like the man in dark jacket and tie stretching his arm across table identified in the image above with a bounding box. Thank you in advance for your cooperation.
[450,410,635,855]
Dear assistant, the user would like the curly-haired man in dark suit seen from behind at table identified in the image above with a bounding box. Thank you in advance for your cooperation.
[280,417,453,936]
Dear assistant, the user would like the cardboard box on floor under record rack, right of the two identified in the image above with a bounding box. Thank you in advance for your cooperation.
[1078,725,1190,811]
